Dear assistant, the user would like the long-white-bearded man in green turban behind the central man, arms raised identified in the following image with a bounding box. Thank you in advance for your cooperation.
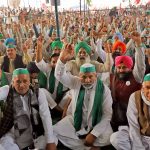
[66,42,111,76]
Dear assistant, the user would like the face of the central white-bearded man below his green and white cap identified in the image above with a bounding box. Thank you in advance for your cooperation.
[79,72,97,88]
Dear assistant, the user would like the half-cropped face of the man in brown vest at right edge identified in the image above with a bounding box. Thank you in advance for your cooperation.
[142,81,150,101]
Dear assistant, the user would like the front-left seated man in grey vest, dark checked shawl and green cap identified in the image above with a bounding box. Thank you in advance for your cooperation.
[0,68,56,150]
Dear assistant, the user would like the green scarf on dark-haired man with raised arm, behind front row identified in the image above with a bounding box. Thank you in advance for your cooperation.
[49,68,63,103]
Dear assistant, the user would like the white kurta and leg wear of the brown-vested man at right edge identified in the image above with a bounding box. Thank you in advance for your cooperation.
[110,93,150,150]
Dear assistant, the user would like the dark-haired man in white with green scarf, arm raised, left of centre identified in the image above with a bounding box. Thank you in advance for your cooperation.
[36,40,68,114]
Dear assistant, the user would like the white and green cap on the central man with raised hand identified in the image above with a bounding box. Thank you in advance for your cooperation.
[80,63,96,73]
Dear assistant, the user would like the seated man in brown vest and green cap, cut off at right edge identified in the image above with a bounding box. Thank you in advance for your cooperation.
[112,74,150,150]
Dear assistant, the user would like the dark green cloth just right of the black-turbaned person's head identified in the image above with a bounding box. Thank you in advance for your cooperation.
[38,71,47,89]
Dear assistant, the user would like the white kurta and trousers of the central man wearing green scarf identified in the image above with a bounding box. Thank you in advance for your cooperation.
[54,60,112,150]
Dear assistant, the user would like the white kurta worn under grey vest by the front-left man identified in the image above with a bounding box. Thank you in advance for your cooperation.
[0,86,57,150]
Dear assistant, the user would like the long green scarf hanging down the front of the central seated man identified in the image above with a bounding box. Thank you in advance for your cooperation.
[74,79,104,131]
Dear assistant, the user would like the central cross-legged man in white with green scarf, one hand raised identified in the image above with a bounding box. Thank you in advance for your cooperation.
[54,45,112,150]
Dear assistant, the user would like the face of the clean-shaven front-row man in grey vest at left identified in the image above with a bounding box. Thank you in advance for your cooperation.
[12,74,30,95]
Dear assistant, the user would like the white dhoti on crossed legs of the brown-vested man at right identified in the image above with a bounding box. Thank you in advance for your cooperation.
[110,126,150,150]
